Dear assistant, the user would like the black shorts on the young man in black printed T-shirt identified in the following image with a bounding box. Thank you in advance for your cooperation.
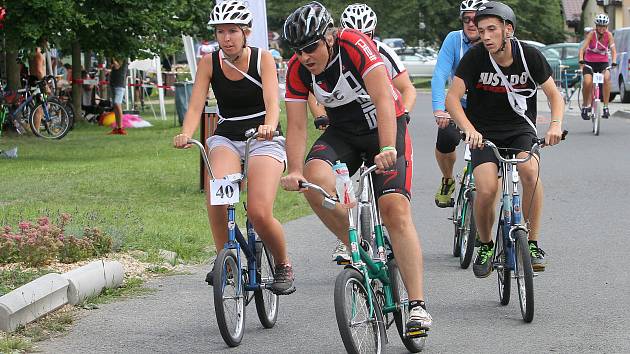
[470,129,537,170]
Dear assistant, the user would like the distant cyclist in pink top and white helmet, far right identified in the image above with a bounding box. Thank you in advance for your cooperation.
[578,14,617,120]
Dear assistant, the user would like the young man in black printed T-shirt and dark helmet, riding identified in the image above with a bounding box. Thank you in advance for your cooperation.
[446,1,564,278]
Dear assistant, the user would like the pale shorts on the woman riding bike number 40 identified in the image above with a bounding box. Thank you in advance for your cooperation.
[206,135,287,166]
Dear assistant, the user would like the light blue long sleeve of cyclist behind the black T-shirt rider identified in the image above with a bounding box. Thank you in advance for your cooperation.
[431,31,461,111]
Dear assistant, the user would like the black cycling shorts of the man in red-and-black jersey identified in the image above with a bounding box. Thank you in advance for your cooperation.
[306,114,413,200]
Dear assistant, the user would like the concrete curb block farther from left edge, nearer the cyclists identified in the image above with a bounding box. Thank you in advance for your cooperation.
[62,260,125,305]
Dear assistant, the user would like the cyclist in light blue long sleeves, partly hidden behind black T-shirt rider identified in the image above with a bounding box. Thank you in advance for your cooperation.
[431,0,488,208]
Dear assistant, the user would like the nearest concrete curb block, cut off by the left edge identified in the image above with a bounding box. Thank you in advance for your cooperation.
[0,273,68,332]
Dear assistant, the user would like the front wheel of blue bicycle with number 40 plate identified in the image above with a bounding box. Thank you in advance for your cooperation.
[213,249,245,347]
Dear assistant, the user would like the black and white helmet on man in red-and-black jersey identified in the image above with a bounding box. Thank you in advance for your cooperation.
[284,1,333,48]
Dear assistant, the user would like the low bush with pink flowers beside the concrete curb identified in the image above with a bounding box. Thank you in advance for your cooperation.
[0,214,112,267]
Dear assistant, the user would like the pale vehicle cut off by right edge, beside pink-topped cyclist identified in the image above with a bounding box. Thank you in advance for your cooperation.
[610,27,630,103]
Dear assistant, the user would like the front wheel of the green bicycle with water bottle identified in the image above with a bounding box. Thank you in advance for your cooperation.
[334,268,383,353]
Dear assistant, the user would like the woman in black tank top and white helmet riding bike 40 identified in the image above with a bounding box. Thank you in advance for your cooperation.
[173,0,295,295]
